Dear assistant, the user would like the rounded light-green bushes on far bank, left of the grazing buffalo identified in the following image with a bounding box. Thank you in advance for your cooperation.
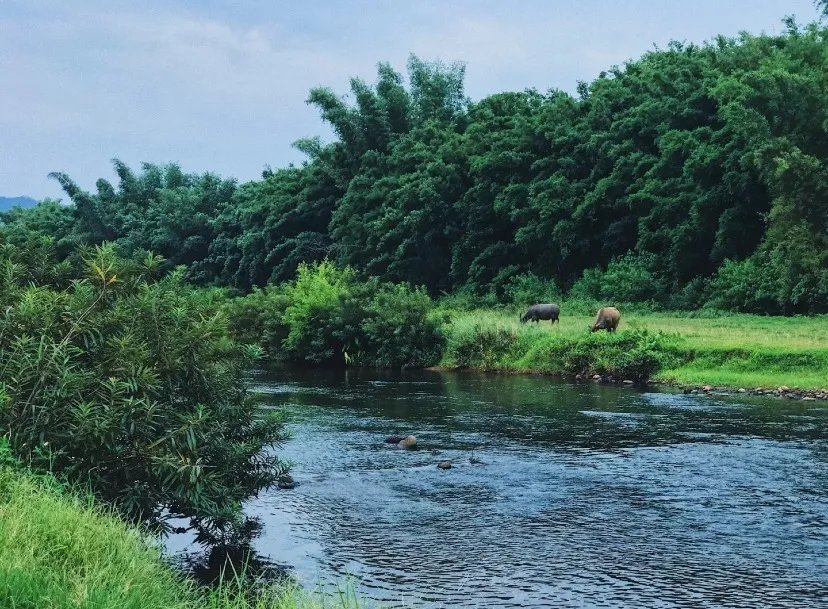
[227,260,443,368]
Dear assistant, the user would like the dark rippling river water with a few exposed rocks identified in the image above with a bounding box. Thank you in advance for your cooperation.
[167,370,828,609]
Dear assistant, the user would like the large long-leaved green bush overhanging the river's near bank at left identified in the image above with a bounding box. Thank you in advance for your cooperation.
[0,240,282,535]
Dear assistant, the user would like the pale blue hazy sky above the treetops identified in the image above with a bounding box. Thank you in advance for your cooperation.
[0,0,817,199]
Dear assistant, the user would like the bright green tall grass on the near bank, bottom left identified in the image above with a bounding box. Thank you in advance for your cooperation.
[0,466,372,609]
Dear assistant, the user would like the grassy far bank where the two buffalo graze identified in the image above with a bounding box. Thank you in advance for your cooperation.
[442,303,828,390]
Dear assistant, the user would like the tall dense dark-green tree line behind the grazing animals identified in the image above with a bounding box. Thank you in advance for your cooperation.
[3,19,828,314]
